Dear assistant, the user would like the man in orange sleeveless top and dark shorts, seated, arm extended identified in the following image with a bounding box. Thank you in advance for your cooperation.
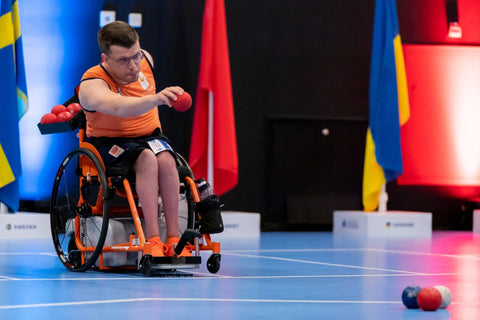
[77,21,191,257]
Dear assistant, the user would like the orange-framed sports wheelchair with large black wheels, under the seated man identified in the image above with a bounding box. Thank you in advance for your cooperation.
[38,97,223,275]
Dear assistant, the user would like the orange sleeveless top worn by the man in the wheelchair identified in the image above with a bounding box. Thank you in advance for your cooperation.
[81,58,161,137]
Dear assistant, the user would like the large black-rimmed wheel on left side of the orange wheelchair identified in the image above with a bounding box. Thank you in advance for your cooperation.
[50,148,110,272]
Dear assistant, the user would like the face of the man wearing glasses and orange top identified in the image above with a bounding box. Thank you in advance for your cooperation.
[102,41,143,85]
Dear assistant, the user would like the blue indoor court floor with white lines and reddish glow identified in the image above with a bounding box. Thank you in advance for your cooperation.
[0,232,480,320]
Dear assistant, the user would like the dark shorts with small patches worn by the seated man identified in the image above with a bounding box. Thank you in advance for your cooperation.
[85,129,175,175]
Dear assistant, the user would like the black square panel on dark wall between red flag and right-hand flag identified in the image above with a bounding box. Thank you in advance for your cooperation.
[264,116,367,229]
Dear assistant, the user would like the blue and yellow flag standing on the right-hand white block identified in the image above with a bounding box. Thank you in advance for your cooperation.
[363,0,410,211]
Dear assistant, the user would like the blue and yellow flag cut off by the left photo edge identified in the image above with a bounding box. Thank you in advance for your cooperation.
[0,0,28,211]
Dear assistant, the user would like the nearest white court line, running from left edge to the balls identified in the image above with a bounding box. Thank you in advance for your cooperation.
[0,298,402,310]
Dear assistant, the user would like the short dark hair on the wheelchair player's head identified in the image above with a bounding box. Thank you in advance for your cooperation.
[97,21,138,54]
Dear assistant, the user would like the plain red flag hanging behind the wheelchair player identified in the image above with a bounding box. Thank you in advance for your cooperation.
[189,0,238,195]
